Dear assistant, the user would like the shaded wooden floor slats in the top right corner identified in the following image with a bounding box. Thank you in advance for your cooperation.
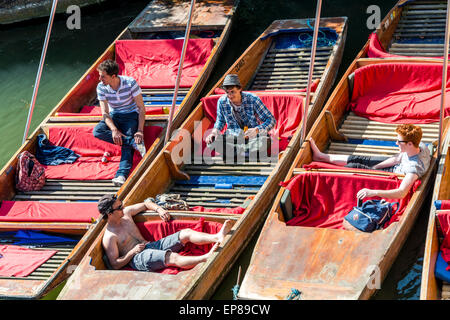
[388,1,447,57]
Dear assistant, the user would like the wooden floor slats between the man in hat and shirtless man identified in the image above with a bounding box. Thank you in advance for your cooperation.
[168,157,275,208]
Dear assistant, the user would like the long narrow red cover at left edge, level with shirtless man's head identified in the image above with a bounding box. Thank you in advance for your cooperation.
[0,201,99,222]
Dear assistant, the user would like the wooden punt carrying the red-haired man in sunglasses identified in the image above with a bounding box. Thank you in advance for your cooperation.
[238,53,447,300]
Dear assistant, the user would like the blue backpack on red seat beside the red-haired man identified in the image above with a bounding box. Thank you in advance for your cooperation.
[344,199,400,232]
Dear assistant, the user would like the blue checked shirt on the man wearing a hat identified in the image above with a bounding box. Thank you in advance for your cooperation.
[214,92,276,135]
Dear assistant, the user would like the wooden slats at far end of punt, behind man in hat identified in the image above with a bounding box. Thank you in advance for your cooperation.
[250,43,333,90]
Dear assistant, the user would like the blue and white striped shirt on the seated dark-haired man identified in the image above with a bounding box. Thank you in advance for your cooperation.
[97,76,142,113]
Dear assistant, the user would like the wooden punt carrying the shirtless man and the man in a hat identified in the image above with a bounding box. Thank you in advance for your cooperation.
[58,17,347,299]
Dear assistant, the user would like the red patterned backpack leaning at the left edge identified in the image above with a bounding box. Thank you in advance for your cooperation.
[16,151,45,191]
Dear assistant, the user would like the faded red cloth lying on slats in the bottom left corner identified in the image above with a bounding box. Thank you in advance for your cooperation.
[0,245,57,277]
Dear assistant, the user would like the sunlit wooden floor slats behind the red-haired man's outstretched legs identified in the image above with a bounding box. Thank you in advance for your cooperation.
[326,112,439,156]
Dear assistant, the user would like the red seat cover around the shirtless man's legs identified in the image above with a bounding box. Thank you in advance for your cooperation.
[137,218,222,274]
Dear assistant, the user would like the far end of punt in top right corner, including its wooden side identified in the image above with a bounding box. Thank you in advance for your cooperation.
[364,0,447,58]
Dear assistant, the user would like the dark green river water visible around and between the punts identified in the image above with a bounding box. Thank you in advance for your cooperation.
[0,0,430,299]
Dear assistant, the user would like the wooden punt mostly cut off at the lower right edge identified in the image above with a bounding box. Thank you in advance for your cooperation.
[420,126,450,300]
